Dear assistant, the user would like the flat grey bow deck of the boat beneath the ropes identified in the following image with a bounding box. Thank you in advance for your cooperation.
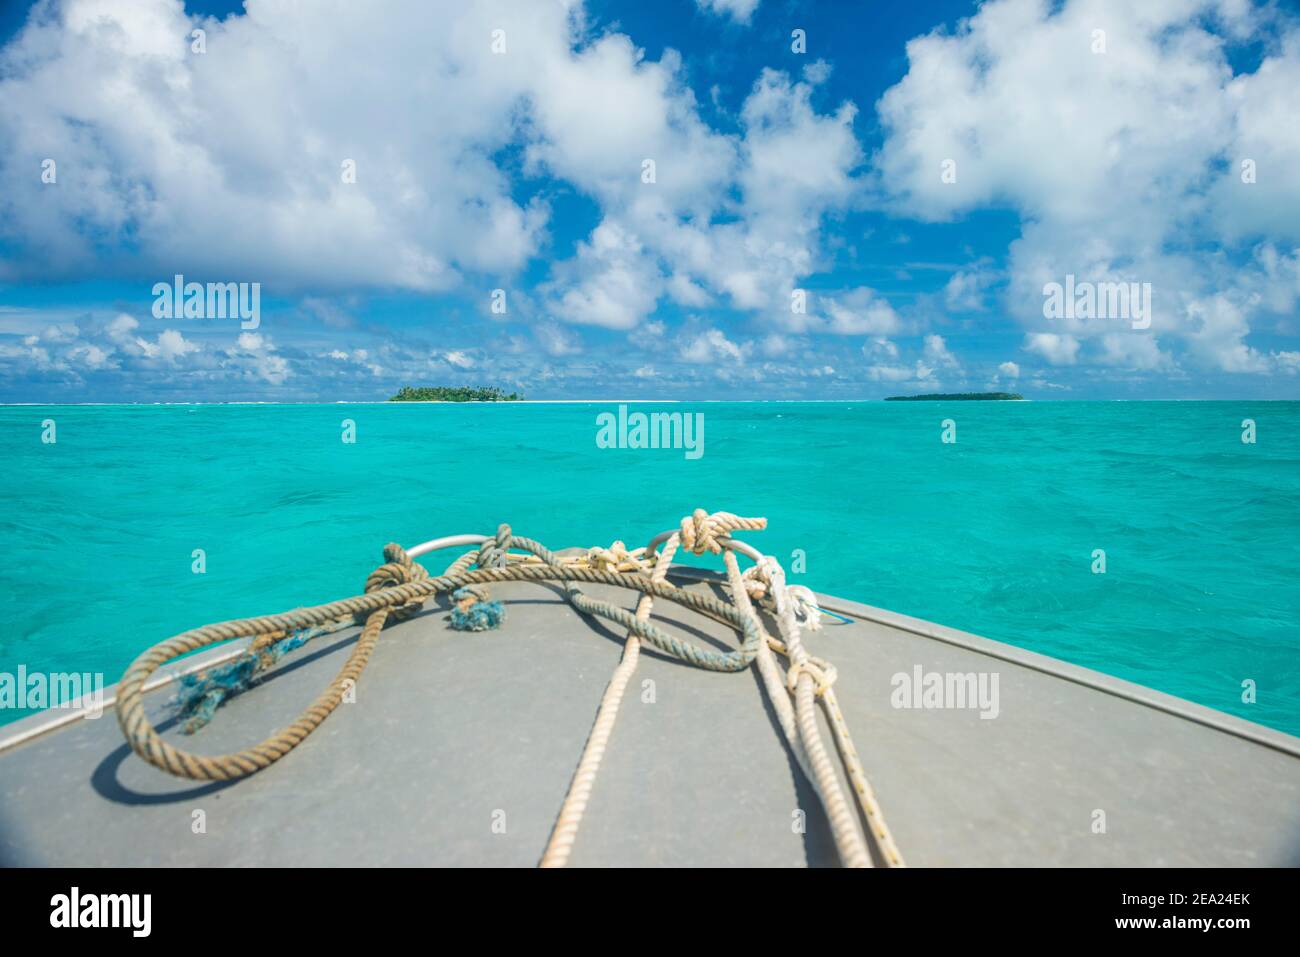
[0,572,1300,866]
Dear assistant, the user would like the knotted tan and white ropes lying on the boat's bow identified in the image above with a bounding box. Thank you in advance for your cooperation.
[117,508,904,867]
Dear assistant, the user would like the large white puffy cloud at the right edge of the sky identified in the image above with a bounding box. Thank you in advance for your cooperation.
[875,0,1300,372]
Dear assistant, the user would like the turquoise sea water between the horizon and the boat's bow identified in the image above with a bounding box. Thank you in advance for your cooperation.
[0,402,1300,733]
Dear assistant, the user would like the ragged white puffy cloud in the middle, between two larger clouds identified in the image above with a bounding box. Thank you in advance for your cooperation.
[543,61,862,332]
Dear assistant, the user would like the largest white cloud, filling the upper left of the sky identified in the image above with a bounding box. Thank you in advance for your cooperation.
[0,0,571,290]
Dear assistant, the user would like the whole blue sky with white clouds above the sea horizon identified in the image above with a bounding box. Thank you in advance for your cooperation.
[0,0,1300,402]
